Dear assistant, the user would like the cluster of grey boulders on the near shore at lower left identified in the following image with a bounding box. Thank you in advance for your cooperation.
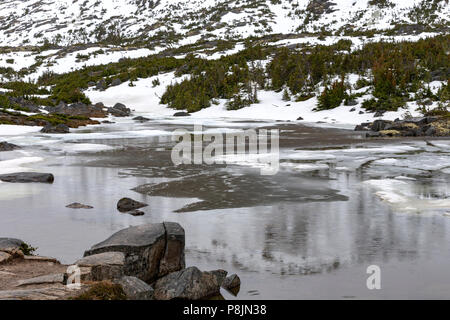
[0,222,240,300]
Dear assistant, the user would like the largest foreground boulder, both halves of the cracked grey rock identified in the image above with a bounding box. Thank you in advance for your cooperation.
[84,222,185,283]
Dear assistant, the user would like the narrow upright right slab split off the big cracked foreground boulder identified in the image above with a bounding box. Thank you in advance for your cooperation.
[158,222,186,277]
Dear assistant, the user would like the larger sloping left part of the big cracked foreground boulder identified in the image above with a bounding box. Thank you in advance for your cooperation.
[84,223,166,282]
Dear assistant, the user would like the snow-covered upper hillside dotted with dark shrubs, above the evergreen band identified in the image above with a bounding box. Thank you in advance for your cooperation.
[0,0,450,46]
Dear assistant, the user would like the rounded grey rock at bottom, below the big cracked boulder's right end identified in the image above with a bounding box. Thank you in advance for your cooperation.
[154,267,220,300]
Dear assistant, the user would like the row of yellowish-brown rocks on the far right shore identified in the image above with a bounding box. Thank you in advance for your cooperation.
[355,117,450,137]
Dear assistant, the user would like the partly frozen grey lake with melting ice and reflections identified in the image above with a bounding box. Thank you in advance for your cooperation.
[0,119,450,299]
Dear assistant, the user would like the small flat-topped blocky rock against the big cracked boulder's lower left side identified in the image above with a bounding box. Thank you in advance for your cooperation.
[75,252,125,281]
